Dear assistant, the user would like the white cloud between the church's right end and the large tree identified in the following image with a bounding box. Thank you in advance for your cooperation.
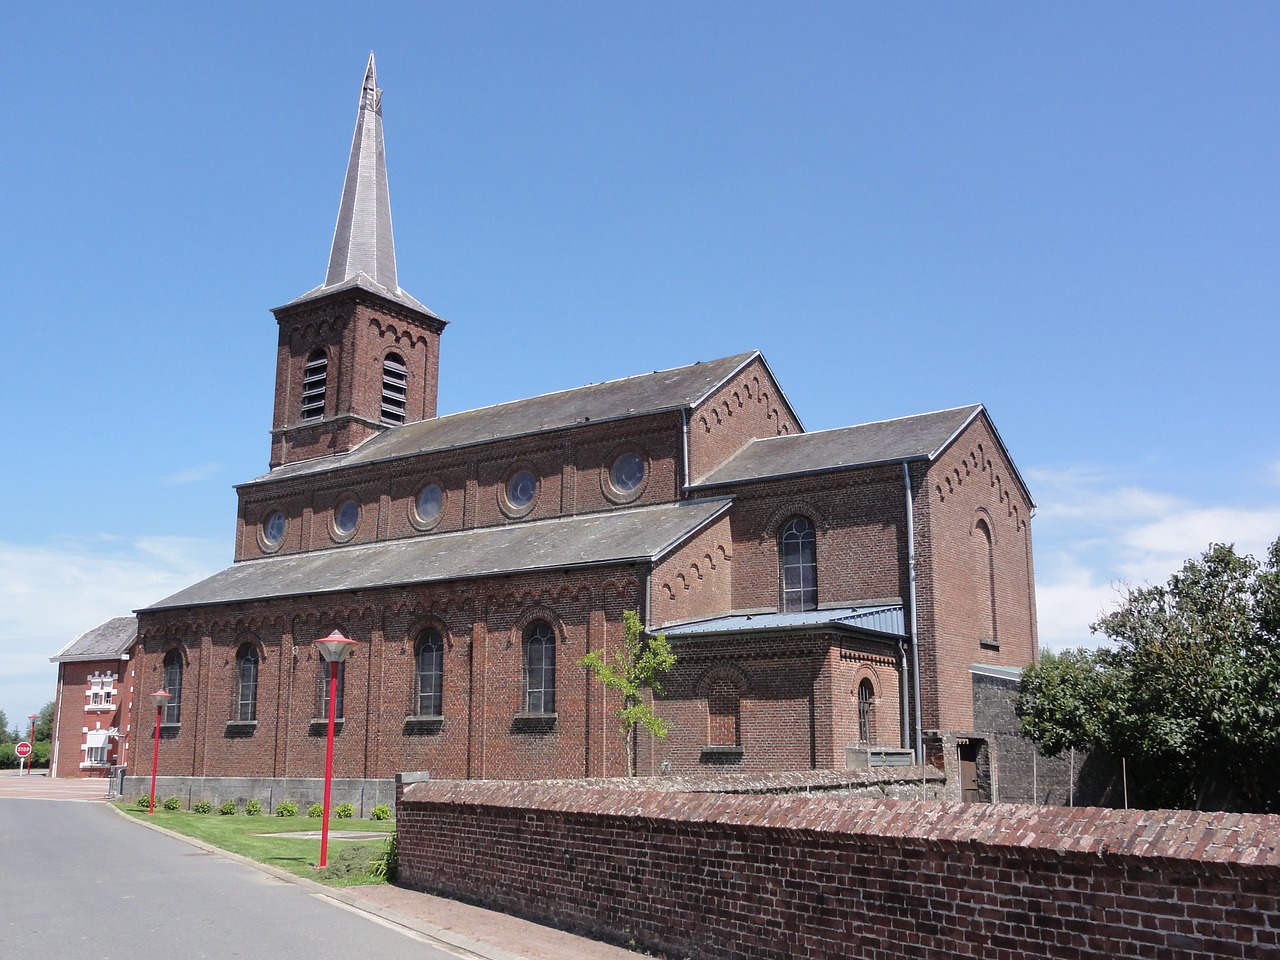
[1028,467,1280,650]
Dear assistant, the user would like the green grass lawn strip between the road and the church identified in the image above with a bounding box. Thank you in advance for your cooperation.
[116,797,396,887]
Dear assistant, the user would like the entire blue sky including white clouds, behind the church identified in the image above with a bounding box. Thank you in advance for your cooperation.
[0,3,1280,721]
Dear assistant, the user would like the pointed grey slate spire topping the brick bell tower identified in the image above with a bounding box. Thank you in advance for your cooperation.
[294,54,435,316]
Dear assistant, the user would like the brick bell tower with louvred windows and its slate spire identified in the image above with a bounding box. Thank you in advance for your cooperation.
[271,54,447,470]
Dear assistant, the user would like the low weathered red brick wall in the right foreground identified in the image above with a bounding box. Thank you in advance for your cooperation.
[397,781,1280,960]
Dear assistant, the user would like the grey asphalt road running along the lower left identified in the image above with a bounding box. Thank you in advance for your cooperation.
[0,800,457,960]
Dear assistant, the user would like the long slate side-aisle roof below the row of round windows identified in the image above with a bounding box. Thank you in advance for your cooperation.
[143,497,732,611]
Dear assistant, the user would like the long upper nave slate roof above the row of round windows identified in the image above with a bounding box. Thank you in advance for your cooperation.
[241,351,759,486]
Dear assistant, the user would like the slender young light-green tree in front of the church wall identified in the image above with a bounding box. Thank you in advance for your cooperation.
[577,611,676,777]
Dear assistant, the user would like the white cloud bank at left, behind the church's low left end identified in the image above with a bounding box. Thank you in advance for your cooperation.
[0,536,228,719]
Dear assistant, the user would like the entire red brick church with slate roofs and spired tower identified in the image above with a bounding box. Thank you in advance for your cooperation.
[67,58,1037,798]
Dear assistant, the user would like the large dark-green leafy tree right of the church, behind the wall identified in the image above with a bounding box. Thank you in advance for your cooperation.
[1015,539,1280,813]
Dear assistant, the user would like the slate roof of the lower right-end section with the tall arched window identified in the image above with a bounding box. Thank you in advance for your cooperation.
[694,403,982,486]
